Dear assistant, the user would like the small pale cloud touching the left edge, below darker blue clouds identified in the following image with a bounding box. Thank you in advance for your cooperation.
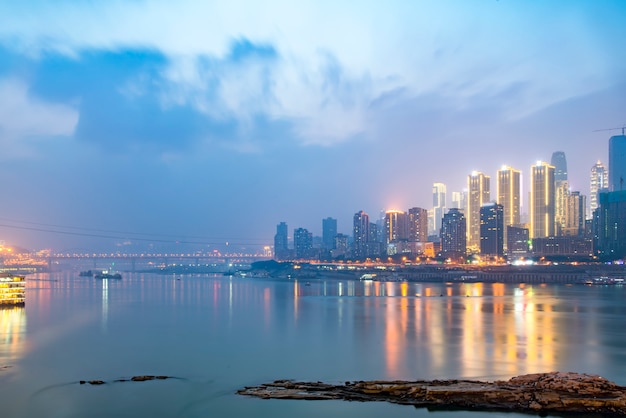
[0,78,78,158]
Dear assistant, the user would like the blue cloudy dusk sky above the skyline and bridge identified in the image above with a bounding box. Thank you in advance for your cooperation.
[0,0,626,251]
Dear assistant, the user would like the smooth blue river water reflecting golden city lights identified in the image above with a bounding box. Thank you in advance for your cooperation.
[0,273,626,418]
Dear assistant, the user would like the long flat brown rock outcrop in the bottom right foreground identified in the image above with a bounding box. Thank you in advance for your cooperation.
[237,372,626,416]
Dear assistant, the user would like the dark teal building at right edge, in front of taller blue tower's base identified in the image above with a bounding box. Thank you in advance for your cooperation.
[594,191,626,260]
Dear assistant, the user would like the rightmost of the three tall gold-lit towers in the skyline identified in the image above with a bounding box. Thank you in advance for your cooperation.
[529,161,556,238]
